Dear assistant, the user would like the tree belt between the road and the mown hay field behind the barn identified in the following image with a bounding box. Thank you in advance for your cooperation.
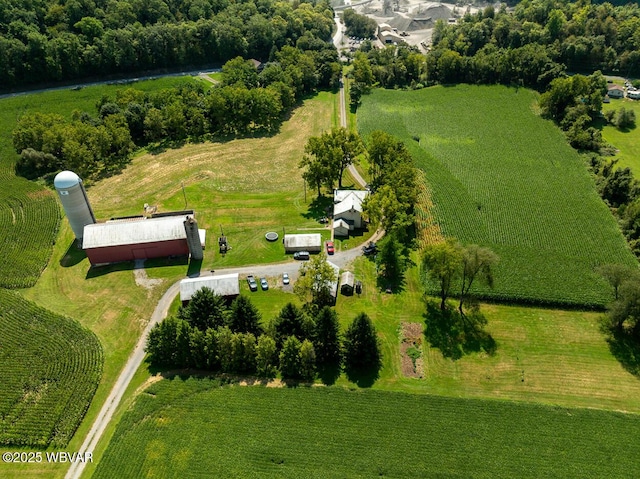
[13,45,340,180]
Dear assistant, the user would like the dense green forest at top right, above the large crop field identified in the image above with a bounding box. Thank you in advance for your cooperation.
[428,0,640,82]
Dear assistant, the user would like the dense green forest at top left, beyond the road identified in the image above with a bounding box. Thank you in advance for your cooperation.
[0,0,333,89]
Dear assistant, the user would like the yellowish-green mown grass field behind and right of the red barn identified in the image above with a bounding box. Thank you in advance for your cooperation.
[87,92,336,275]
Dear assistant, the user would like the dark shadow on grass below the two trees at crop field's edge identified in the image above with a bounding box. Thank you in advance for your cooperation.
[423,301,498,360]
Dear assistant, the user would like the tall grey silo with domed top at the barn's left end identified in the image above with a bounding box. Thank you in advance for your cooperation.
[53,171,96,240]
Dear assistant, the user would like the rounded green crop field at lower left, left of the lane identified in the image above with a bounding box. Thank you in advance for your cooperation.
[0,289,103,447]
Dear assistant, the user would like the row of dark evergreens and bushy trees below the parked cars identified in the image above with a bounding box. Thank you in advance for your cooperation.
[146,288,382,385]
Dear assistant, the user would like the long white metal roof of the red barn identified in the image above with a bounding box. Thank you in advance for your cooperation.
[82,215,191,249]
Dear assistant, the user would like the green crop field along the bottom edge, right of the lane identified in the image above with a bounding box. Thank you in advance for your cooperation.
[92,379,640,479]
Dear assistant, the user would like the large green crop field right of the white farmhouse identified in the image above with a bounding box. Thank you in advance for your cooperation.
[358,85,637,307]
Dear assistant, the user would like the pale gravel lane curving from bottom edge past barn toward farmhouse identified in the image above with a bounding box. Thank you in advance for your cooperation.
[65,231,384,479]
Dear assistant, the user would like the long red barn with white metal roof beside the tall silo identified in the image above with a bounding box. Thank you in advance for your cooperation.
[82,214,204,265]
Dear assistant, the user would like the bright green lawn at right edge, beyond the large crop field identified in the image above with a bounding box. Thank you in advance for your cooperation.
[602,99,640,172]
